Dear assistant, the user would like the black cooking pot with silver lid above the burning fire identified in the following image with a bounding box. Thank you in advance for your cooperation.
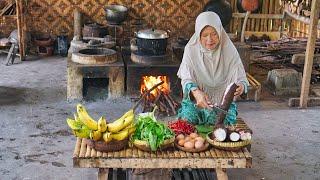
[136,29,169,56]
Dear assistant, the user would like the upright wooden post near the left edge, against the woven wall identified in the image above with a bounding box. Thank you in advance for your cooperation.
[16,0,25,60]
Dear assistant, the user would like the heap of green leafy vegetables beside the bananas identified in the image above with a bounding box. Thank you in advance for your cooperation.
[132,107,174,151]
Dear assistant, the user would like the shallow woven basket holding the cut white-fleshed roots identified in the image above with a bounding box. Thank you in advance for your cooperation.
[207,133,251,151]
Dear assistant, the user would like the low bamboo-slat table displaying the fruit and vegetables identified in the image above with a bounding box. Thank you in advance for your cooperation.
[73,118,252,180]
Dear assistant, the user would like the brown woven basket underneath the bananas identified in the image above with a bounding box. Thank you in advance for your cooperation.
[86,138,129,152]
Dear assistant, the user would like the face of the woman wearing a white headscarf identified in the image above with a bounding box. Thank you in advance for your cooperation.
[200,26,220,50]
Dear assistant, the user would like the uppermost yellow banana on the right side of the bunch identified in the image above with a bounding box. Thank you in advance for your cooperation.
[107,109,134,133]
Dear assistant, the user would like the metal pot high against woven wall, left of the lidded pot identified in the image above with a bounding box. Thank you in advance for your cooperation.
[105,5,128,24]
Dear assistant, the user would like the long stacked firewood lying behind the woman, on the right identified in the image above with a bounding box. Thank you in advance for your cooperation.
[250,37,320,63]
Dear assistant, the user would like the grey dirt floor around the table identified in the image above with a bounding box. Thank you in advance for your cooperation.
[0,56,320,180]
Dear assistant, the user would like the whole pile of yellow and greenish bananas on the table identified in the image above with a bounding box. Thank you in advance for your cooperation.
[67,104,136,142]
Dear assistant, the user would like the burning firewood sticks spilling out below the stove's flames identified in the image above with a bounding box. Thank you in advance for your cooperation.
[142,89,179,116]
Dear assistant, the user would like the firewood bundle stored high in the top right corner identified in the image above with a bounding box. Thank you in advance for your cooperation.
[280,0,312,17]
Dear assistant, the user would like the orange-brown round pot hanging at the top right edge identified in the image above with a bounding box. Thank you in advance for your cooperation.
[237,0,262,13]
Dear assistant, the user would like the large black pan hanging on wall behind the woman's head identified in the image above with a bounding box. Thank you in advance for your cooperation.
[203,0,232,27]
